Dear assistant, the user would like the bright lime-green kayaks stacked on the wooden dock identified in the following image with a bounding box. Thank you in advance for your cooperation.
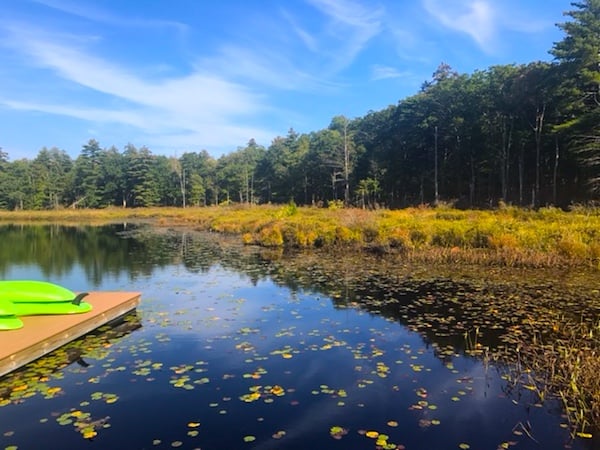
[0,280,92,330]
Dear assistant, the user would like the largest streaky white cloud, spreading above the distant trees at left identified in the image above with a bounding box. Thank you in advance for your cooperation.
[0,26,273,151]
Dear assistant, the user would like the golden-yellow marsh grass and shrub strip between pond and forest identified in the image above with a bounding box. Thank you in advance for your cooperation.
[0,205,600,269]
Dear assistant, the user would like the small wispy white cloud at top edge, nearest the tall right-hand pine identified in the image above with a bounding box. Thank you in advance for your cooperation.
[423,0,497,53]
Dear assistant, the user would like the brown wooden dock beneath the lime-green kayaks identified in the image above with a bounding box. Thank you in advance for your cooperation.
[0,292,141,377]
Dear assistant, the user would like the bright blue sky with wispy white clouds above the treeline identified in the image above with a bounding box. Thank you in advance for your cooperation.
[0,0,572,160]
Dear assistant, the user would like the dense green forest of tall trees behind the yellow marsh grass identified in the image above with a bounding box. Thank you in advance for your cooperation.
[0,0,600,209]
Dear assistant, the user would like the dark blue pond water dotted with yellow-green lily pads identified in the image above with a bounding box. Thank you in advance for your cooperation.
[0,224,598,450]
